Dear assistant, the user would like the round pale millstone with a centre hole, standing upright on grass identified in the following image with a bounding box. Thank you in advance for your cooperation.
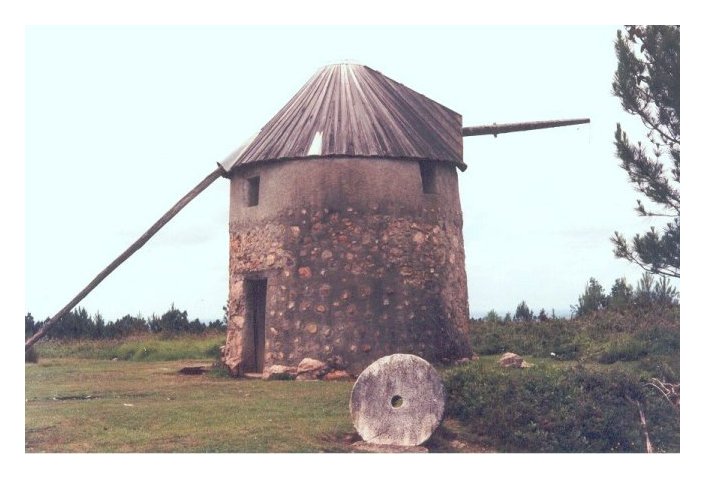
[350,354,445,446]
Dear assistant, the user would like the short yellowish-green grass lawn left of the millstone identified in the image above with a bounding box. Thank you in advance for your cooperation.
[25,359,354,452]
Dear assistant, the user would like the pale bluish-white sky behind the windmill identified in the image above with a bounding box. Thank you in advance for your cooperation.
[25,26,678,320]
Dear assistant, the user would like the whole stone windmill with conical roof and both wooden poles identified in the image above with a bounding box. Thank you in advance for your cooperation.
[25,64,589,376]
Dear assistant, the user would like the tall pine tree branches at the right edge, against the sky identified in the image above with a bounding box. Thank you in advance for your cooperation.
[611,25,680,277]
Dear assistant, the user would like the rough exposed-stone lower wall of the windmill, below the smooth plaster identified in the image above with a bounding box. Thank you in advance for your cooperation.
[224,157,470,375]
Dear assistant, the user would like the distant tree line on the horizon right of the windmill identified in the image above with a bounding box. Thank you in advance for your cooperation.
[473,272,680,321]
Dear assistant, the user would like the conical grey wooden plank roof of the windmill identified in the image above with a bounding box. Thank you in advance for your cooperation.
[224,63,466,170]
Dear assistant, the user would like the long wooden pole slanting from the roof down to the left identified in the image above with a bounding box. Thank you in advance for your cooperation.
[24,165,225,352]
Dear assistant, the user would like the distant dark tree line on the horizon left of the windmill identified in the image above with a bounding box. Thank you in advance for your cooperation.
[24,304,227,339]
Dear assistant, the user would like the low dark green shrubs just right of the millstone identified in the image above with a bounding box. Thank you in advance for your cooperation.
[444,361,680,452]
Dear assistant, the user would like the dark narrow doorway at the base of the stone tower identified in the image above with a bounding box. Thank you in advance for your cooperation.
[243,279,267,373]
